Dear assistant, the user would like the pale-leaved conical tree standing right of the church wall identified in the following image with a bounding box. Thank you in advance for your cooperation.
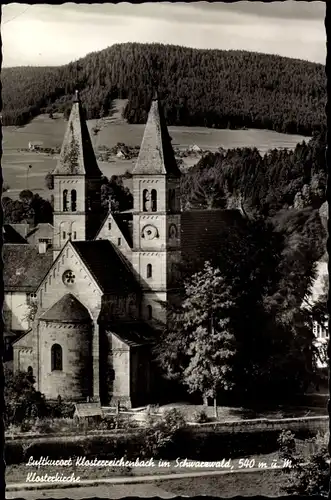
[157,262,235,417]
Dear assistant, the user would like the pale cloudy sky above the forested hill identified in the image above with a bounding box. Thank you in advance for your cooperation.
[1,0,326,67]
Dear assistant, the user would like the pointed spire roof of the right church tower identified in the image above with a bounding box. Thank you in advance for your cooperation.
[132,98,180,177]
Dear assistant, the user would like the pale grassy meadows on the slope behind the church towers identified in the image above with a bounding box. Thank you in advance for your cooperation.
[2,101,307,202]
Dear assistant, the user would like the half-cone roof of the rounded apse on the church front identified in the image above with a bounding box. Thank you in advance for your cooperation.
[39,293,91,323]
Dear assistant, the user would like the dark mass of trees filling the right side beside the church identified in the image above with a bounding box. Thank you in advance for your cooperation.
[155,131,328,405]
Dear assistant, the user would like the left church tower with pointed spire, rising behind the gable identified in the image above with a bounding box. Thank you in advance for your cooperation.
[52,91,102,258]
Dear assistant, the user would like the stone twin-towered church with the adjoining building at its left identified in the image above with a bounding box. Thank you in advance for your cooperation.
[3,92,241,408]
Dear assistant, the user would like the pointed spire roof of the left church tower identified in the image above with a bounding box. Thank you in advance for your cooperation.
[53,91,102,177]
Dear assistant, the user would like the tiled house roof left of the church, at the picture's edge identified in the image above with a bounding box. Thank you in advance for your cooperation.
[2,244,53,292]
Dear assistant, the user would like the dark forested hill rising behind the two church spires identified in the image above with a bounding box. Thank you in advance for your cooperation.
[2,43,326,135]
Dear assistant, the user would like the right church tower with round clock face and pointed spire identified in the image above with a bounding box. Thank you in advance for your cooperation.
[132,97,181,323]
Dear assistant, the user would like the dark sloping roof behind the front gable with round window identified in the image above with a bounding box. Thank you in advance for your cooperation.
[71,240,139,294]
